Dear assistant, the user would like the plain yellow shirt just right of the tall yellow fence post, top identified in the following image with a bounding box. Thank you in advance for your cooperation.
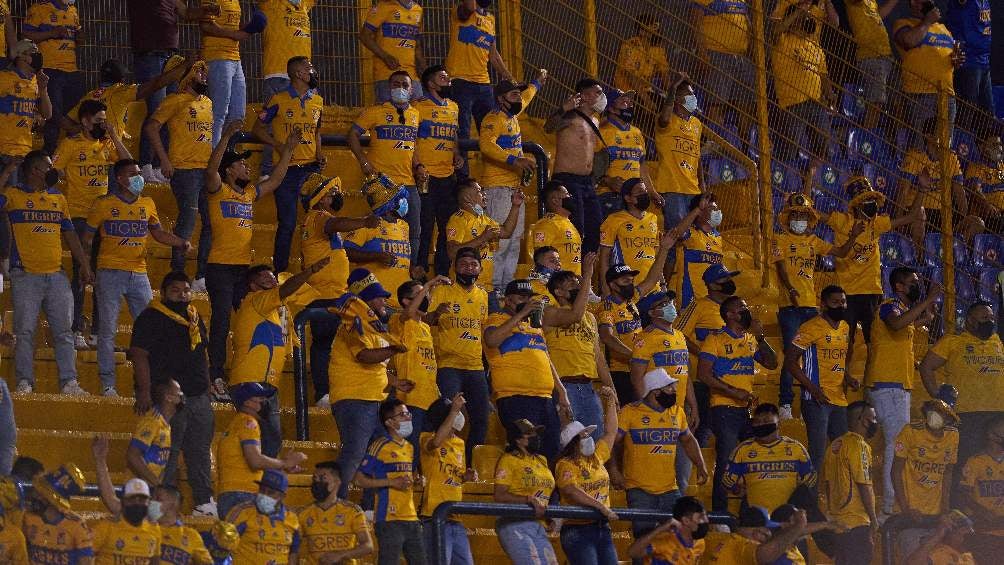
[771,32,827,108]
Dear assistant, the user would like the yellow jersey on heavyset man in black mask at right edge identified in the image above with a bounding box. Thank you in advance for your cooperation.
[930,331,1004,413]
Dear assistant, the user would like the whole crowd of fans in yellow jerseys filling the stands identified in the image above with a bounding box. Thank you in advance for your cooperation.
[0,0,1004,565]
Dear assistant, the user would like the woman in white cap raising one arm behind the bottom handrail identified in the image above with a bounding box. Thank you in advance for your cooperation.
[554,386,617,565]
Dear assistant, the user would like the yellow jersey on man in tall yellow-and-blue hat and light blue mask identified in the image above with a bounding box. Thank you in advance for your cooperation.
[344,218,412,308]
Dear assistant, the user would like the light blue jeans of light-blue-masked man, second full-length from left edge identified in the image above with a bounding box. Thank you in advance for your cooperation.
[94,269,154,388]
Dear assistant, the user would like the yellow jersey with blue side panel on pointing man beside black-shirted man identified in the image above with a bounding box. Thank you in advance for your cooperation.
[230,286,290,386]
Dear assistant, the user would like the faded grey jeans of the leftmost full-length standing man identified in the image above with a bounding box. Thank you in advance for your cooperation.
[10,269,77,385]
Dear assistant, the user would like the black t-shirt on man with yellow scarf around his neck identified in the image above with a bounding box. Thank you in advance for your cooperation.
[130,308,209,396]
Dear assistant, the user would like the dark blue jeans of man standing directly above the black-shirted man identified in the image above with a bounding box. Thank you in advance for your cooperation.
[171,169,213,279]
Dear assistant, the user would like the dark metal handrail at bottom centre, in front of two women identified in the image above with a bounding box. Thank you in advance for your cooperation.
[431,502,735,565]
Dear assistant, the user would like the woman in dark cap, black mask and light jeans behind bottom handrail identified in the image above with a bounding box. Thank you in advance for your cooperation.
[495,418,558,565]
